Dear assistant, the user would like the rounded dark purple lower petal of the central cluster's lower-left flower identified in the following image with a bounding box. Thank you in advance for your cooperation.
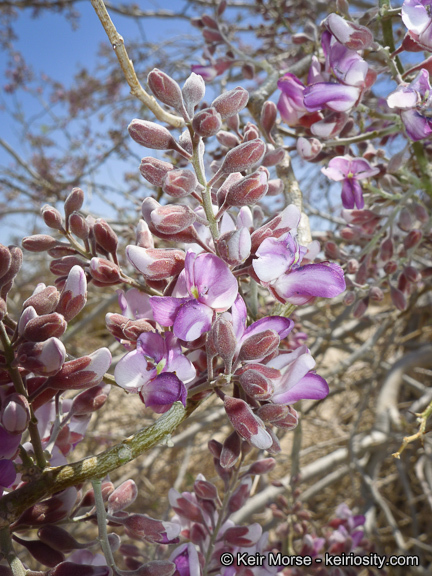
[141,372,187,414]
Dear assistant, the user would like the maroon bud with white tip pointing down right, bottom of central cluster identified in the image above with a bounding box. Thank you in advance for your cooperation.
[224,396,273,450]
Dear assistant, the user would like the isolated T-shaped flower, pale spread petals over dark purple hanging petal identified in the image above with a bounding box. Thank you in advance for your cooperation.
[321,155,379,210]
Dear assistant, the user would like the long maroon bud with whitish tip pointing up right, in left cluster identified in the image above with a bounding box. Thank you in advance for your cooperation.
[47,348,111,390]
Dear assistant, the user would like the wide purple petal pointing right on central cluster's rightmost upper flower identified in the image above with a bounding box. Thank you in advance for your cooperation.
[273,262,346,305]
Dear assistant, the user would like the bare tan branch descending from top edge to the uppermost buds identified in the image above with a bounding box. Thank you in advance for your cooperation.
[91,0,185,128]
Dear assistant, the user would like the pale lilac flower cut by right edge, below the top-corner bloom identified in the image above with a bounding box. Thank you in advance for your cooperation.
[387,68,432,141]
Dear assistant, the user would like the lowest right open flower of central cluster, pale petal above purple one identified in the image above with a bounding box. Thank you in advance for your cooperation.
[267,346,329,404]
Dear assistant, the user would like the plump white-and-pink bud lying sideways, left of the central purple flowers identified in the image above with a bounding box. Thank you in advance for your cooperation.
[126,246,185,280]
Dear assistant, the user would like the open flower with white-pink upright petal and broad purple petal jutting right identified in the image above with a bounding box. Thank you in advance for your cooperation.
[252,232,345,305]
